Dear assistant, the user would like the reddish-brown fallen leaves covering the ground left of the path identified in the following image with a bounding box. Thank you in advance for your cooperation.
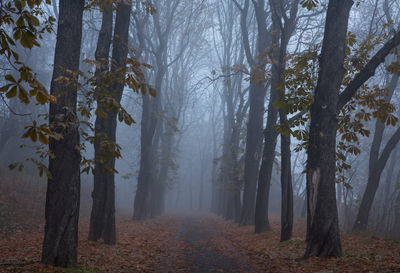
[0,216,182,272]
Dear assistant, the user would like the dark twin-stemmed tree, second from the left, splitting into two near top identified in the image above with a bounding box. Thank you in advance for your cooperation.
[89,1,132,244]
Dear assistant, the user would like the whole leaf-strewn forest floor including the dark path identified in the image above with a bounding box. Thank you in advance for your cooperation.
[0,175,400,273]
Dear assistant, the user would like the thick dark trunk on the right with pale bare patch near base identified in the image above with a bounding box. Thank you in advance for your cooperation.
[304,0,353,258]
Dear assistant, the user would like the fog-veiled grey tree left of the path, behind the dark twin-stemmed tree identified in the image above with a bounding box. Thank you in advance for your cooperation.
[133,1,185,220]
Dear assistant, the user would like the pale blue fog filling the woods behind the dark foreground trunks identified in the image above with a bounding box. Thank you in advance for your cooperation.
[0,0,400,268]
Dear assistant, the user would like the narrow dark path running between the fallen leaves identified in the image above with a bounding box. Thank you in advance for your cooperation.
[177,216,254,273]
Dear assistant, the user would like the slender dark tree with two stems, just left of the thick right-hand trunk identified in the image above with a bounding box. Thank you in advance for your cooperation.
[255,0,299,235]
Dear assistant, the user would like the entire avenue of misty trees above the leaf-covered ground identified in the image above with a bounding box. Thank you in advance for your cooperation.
[0,0,400,267]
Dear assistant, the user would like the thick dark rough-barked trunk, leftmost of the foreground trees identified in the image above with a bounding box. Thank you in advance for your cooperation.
[42,0,84,267]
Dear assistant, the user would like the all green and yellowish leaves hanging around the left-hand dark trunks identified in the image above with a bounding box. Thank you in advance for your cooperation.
[0,0,157,176]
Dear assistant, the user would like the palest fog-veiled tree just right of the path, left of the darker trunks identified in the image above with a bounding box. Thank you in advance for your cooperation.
[213,1,248,221]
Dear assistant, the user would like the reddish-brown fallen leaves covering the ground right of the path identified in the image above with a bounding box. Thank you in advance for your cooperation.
[206,216,400,272]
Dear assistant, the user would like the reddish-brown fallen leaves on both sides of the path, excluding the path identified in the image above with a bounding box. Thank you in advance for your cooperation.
[0,211,400,272]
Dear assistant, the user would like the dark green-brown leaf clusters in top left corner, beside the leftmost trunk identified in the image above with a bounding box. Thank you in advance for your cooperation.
[0,0,56,104]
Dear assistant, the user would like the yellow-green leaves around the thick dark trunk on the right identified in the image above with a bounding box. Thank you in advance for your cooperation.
[275,32,399,187]
